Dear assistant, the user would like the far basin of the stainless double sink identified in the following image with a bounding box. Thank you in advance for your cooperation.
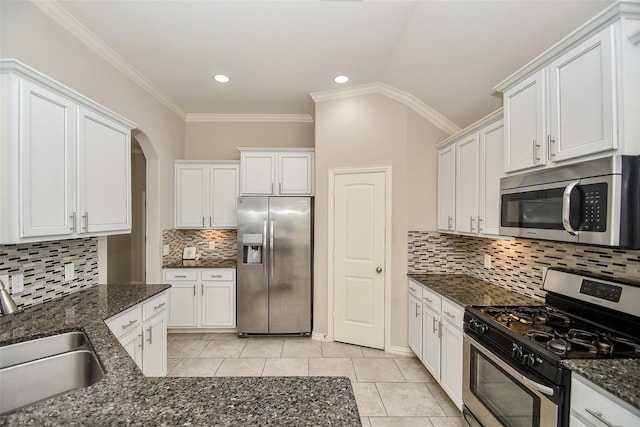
[0,332,88,369]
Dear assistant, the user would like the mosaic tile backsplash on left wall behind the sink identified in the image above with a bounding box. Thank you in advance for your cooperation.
[0,238,98,308]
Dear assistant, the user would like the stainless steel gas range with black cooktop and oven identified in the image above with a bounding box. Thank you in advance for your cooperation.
[462,269,640,427]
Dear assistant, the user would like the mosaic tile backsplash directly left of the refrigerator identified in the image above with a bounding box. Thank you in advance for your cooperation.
[162,229,238,265]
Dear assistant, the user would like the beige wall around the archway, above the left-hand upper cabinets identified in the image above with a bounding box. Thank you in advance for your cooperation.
[0,1,184,283]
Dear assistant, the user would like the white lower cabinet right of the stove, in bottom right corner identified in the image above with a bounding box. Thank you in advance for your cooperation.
[569,372,640,427]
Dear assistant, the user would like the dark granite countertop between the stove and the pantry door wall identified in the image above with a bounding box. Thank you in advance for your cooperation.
[409,274,542,307]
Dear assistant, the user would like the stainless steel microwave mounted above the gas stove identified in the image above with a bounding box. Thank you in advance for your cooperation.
[500,156,640,249]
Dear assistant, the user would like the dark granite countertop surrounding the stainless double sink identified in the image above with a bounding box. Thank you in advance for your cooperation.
[0,285,360,426]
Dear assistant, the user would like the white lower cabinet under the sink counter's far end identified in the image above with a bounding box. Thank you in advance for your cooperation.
[105,292,168,377]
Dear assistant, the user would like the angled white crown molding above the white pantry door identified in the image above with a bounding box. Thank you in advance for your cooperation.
[310,82,460,135]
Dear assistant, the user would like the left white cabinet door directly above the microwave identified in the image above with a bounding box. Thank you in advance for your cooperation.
[503,71,546,172]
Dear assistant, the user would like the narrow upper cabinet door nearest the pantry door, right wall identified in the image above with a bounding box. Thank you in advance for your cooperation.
[438,144,456,230]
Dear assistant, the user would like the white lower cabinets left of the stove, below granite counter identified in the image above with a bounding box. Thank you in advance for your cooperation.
[409,279,464,410]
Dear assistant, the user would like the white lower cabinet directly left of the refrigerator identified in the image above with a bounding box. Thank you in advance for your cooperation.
[164,268,236,329]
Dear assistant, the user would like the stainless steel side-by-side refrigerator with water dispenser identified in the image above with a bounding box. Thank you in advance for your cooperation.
[237,197,313,336]
